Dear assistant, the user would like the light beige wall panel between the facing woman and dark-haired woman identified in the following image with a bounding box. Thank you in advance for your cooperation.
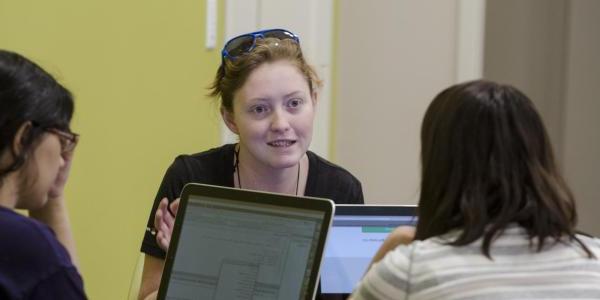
[334,0,457,203]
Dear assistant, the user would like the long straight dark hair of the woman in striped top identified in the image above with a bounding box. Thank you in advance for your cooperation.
[416,80,593,257]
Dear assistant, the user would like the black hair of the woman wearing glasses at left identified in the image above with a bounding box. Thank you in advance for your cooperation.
[0,49,73,184]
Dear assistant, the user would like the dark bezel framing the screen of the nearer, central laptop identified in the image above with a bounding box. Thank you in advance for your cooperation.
[157,183,335,299]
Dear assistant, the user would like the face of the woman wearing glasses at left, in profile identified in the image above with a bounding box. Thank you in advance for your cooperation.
[17,133,65,209]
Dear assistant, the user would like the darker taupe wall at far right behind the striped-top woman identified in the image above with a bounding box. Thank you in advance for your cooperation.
[484,0,600,235]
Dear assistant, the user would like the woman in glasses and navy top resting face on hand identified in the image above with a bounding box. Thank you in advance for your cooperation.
[0,50,86,299]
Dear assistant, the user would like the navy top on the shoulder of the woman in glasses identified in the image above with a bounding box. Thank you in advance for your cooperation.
[0,210,86,299]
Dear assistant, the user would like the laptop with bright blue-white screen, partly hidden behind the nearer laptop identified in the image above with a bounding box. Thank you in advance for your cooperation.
[321,205,416,299]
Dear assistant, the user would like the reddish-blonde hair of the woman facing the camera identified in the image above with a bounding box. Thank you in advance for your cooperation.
[209,38,321,112]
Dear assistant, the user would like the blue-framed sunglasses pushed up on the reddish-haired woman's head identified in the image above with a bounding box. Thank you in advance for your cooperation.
[221,29,300,61]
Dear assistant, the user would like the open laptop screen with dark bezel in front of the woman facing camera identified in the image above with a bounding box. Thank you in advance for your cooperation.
[158,184,335,300]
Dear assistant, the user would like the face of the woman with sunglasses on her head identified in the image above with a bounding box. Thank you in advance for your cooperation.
[224,61,316,169]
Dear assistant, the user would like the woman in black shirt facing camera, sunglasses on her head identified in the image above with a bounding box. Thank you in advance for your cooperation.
[139,29,364,299]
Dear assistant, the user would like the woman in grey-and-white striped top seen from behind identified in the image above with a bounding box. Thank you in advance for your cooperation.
[352,80,600,299]
